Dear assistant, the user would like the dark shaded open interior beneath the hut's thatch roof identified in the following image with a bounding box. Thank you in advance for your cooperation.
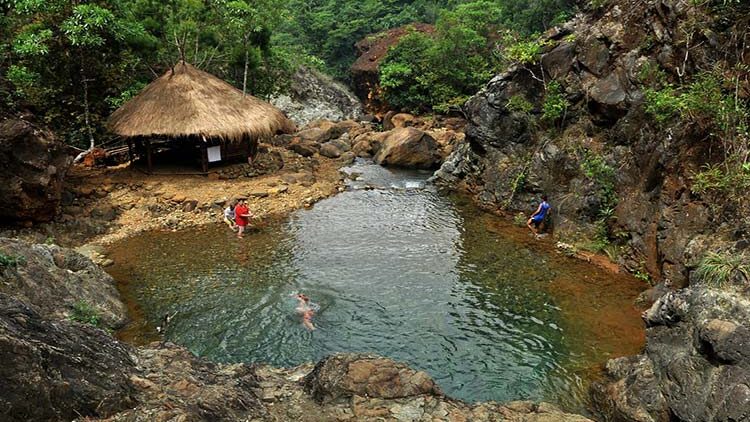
[127,136,258,175]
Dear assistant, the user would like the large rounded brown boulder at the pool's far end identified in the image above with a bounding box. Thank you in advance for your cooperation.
[375,127,441,169]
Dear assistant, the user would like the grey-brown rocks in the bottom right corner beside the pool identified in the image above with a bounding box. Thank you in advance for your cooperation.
[594,287,750,422]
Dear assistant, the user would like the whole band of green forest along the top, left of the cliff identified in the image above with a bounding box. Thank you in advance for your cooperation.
[0,0,570,147]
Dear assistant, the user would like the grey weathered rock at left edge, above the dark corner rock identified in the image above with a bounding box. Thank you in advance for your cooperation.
[0,238,127,328]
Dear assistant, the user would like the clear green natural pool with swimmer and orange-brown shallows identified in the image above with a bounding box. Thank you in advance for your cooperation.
[110,161,643,410]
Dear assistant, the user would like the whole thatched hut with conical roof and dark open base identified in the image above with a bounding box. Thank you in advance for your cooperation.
[107,62,294,172]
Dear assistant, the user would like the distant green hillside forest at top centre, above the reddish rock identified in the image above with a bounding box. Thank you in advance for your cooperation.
[280,0,575,78]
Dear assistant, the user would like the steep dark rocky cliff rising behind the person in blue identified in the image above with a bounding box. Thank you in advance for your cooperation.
[436,0,750,286]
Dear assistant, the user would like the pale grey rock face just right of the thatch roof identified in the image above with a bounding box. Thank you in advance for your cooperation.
[271,67,364,127]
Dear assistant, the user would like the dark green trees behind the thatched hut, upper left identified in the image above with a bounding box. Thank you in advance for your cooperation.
[0,0,295,146]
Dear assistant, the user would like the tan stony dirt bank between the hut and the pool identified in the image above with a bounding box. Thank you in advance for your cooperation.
[0,146,349,261]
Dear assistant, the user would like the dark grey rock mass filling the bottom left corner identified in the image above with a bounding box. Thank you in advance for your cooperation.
[0,293,136,421]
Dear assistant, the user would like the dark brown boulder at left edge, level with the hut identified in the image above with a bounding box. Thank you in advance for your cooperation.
[0,118,72,222]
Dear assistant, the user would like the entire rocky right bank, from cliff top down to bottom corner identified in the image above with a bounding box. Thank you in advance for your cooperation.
[435,0,750,422]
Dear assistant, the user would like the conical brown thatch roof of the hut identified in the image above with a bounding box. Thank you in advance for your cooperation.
[107,62,294,141]
